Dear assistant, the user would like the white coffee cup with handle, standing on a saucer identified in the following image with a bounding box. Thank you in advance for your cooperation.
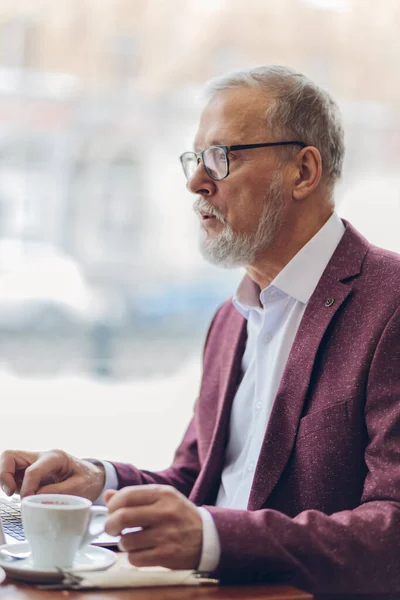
[21,494,106,569]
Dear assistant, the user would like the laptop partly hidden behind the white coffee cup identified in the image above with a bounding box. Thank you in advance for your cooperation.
[0,495,120,547]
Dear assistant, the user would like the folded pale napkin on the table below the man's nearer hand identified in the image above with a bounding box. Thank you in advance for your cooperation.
[38,553,218,590]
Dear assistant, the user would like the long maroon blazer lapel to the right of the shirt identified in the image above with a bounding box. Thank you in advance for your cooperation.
[248,224,369,510]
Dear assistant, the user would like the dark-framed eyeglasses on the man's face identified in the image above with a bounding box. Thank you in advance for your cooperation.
[179,141,307,181]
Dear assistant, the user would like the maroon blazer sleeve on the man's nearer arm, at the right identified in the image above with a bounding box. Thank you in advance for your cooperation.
[207,309,400,597]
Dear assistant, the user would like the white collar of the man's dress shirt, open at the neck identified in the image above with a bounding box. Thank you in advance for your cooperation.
[233,212,345,318]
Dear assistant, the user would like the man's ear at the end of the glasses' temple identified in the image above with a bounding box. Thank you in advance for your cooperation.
[292,146,322,200]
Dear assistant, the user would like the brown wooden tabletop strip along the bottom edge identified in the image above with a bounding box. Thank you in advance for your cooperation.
[0,579,312,600]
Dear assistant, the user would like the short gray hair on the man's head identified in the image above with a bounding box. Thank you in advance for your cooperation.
[206,65,345,185]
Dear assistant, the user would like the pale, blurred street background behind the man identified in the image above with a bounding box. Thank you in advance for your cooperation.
[0,0,400,468]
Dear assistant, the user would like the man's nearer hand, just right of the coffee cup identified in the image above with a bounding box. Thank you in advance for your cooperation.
[104,485,203,569]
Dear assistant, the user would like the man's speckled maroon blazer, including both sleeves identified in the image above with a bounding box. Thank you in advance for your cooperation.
[114,223,400,594]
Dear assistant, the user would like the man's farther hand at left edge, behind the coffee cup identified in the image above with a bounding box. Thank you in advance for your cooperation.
[0,450,105,500]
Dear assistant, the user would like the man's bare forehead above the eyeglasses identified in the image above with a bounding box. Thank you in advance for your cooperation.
[194,87,269,150]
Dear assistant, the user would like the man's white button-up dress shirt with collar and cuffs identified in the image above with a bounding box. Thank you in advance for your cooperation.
[98,213,345,571]
